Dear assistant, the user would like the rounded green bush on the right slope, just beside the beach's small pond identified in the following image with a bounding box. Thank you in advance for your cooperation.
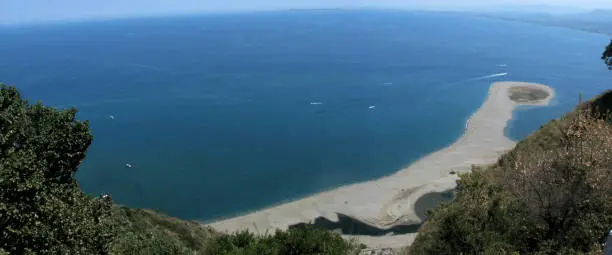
[409,168,534,255]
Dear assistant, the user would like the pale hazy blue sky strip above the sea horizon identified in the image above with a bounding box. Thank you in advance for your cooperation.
[0,0,612,24]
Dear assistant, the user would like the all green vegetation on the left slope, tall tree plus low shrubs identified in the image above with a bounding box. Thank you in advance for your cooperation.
[0,84,355,255]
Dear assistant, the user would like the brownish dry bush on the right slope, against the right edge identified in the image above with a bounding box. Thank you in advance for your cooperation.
[500,110,612,251]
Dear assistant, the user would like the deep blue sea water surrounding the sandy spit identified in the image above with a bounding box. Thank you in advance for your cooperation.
[0,11,612,221]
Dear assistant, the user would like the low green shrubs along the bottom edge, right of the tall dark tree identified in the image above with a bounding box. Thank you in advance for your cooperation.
[111,207,358,255]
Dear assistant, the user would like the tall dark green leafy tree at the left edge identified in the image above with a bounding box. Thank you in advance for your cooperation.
[0,84,115,254]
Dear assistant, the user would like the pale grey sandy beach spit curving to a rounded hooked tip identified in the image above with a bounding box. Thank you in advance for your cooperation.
[209,82,554,248]
